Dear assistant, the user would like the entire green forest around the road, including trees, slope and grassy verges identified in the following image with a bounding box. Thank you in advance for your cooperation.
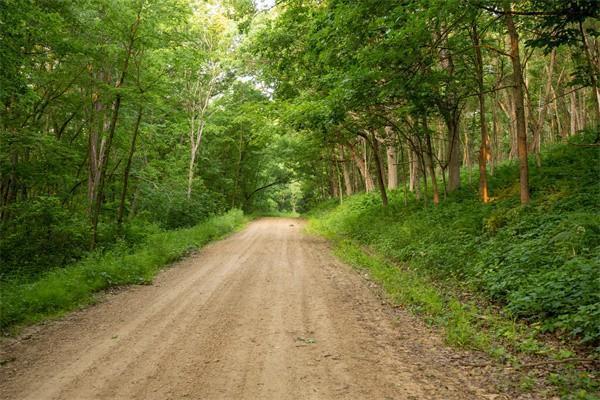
[0,0,600,398]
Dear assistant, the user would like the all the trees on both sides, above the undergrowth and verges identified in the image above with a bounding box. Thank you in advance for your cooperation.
[0,0,600,274]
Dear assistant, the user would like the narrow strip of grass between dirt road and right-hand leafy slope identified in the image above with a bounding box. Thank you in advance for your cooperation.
[308,227,600,400]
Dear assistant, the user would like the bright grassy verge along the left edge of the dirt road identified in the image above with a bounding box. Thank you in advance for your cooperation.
[0,210,248,333]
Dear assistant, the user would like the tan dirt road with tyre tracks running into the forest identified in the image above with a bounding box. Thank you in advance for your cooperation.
[0,218,505,400]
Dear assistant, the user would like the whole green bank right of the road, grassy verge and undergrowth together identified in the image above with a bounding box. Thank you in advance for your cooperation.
[310,138,600,399]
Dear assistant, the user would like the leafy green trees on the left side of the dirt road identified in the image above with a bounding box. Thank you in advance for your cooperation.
[0,0,286,279]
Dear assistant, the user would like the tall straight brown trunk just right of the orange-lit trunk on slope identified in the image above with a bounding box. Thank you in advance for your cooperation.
[504,2,529,204]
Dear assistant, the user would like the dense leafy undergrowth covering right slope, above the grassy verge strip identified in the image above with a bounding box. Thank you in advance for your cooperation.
[313,145,600,344]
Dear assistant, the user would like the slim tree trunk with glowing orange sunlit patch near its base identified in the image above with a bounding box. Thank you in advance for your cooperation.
[471,23,490,203]
